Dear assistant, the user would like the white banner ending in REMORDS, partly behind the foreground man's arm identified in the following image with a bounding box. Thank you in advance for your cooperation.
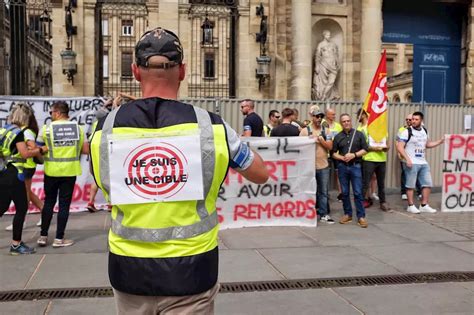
[217,137,317,229]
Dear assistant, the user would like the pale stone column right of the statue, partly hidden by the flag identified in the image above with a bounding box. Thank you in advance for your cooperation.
[360,0,383,101]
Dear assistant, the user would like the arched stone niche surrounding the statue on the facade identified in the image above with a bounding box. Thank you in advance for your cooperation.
[311,18,344,99]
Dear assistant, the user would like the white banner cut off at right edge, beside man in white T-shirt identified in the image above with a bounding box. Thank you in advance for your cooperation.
[441,135,474,212]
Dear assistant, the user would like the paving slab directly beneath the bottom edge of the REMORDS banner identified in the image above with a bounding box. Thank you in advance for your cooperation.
[219,227,317,249]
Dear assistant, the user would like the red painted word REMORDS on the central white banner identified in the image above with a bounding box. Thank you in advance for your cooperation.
[234,199,316,221]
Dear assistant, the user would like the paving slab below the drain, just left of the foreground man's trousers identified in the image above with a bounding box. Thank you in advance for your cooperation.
[48,298,117,315]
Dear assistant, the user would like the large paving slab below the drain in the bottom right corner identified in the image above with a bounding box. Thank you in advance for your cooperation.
[335,283,474,315]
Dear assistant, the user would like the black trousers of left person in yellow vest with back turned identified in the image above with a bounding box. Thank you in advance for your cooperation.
[41,174,76,239]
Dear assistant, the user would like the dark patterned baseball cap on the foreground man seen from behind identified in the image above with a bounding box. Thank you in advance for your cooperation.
[135,27,183,69]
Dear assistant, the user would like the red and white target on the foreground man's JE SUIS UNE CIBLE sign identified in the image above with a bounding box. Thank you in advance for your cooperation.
[123,142,189,200]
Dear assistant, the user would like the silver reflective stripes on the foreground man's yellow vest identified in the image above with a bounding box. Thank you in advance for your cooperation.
[99,106,218,242]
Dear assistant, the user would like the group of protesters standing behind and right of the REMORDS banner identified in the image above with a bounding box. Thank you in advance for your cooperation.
[240,99,444,228]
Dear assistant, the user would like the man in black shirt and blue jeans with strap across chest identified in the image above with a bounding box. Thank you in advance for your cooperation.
[333,114,369,228]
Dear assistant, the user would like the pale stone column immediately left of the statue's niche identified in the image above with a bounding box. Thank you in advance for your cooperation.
[290,0,312,100]
